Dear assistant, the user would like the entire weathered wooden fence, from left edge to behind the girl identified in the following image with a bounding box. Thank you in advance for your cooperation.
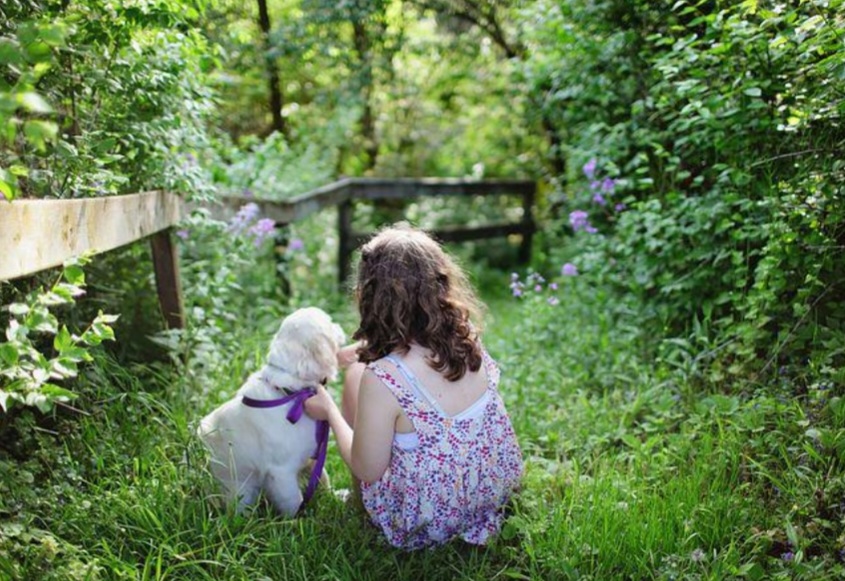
[0,178,536,328]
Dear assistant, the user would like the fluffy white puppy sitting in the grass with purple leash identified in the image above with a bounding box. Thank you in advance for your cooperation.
[198,307,344,515]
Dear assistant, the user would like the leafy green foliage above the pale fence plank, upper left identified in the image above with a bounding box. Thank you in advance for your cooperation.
[0,1,215,199]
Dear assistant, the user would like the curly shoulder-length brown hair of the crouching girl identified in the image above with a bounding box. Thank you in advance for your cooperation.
[353,224,483,381]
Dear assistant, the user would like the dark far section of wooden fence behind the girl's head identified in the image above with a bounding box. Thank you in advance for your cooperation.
[218,178,536,284]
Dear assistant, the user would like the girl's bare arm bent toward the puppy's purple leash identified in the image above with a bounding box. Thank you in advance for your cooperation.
[305,371,400,482]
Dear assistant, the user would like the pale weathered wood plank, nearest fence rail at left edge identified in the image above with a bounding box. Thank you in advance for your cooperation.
[0,191,182,280]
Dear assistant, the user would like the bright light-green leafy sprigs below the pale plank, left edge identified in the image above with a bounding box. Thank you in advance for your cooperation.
[0,259,117,412]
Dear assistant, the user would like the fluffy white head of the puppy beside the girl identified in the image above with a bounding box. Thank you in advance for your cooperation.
[267,307,346,383]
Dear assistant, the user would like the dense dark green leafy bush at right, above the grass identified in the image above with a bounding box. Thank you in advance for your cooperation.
[525,0,845,372]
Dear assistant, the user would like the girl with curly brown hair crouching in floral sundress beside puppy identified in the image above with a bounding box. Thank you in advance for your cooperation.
[306,226,522,549]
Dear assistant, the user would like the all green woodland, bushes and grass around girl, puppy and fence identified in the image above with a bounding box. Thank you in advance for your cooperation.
[0,0,845,579]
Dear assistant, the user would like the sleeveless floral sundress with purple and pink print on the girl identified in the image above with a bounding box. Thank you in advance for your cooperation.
[361,351,522,549]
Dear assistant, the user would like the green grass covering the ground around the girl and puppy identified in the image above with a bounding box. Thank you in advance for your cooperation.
[0,250,845,580]
